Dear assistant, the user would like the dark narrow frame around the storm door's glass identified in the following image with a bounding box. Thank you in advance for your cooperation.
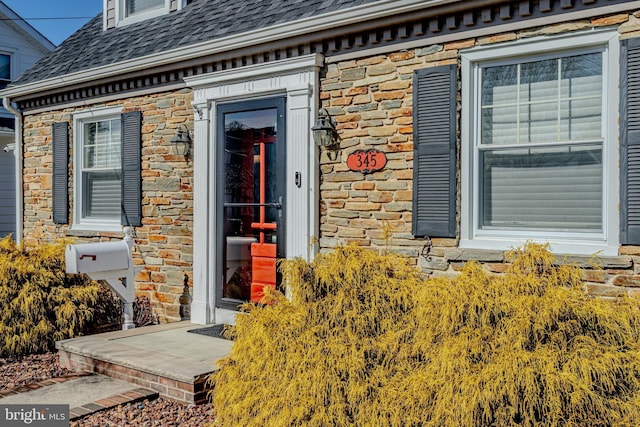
[214,96,287,311]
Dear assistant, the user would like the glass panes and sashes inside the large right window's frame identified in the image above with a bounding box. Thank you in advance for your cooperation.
[477,52,604,232]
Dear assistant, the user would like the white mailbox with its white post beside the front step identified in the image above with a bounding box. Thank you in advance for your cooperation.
[65,227,135,329]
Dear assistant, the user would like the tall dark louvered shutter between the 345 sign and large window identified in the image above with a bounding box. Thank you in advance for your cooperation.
[413,65,457,237]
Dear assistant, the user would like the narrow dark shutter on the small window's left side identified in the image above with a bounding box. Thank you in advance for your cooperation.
[51,122,69,224]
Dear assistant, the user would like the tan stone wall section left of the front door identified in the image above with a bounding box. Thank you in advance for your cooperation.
[24,89,193,322]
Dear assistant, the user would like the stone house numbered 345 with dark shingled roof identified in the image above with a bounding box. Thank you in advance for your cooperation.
[0,0,640,323]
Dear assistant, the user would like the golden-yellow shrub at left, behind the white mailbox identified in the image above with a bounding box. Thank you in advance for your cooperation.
[0,237,120,357]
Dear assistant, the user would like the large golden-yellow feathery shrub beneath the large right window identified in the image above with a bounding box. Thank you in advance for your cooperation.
[211,244,640,427]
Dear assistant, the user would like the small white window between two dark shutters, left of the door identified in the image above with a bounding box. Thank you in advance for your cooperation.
[74,109,122,230]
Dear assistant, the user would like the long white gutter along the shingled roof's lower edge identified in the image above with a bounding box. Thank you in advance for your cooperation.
[0,0,476,98]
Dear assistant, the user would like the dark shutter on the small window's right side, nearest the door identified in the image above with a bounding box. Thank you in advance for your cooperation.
[121,111,142,227]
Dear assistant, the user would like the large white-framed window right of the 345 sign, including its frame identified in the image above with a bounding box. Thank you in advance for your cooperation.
[461,32,618,254]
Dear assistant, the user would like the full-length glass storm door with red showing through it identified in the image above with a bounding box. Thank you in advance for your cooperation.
[216,98,285,309]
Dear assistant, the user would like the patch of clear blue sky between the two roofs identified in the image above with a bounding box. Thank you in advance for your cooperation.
[2,0,102,46]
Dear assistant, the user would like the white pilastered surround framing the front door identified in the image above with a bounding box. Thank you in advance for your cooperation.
[184,54,324,324]
